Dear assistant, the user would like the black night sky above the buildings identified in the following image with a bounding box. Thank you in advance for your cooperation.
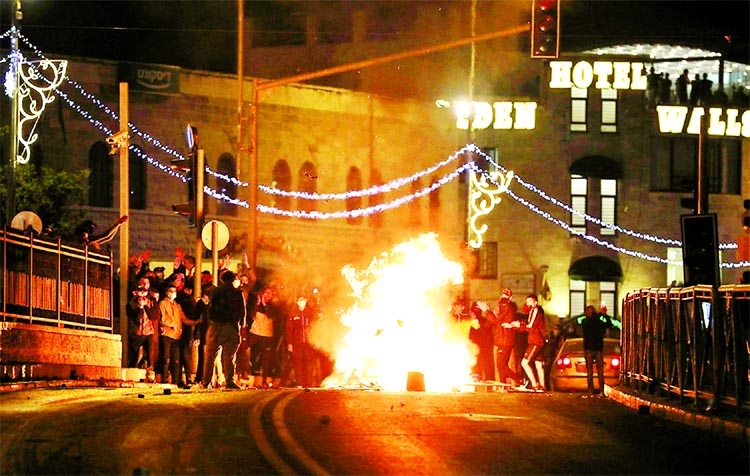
[0,0,750,73]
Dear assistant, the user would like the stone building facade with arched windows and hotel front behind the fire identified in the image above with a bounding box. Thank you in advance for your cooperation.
[2,2,750,324]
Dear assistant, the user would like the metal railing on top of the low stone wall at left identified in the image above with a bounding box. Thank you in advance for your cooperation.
[0,229,114,333]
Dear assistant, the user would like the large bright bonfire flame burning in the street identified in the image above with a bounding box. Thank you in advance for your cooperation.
[322,233,476,391]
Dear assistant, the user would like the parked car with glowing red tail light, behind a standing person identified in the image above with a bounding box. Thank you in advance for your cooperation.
[550,337,622,392]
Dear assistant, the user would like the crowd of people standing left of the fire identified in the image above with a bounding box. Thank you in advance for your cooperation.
[126,250,332,389]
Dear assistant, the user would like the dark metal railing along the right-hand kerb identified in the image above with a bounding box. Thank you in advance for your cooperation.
[622,285,750,411]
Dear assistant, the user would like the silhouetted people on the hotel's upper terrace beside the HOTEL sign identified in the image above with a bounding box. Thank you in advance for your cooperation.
[646,66,750,108]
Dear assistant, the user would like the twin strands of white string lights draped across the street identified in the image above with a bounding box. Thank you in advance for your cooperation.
[0,31,750,268]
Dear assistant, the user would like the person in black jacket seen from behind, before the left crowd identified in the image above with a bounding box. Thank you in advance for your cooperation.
[199,271,245,389]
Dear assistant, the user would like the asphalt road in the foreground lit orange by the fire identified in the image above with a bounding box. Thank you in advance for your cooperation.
[0,386,750,475]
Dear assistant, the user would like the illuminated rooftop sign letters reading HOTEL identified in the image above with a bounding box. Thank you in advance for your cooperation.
[549,61,646,90]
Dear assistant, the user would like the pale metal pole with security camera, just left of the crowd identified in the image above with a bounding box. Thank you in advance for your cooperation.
[118,83,130,368]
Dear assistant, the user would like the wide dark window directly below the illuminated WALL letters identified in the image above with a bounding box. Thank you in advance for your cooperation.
[651,137,742,195]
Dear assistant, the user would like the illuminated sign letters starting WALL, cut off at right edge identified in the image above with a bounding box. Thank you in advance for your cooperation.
[656,106,750,137]
